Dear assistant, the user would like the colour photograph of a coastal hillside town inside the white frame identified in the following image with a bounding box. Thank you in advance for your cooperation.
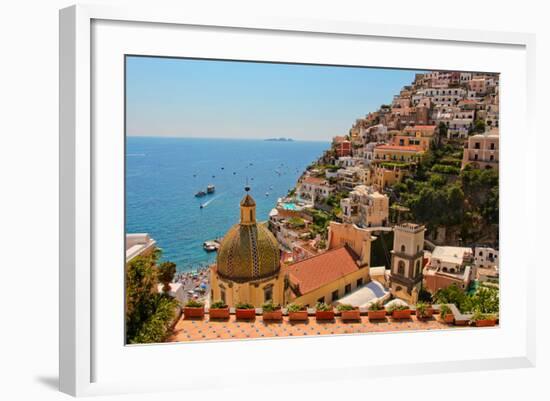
[124,55,500,345]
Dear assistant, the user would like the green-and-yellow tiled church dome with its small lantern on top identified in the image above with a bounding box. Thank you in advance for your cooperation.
[217,194,280,282]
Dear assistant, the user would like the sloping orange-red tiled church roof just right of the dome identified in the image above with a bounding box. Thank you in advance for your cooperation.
[285,246,359,294]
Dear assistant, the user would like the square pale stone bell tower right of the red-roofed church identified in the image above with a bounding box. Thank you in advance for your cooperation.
[389,223,426,304]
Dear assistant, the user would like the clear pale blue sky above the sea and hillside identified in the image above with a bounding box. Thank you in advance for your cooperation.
[126,57,424,140]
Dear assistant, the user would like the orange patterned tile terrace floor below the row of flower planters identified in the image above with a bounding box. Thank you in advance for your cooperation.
[169,315,474,342]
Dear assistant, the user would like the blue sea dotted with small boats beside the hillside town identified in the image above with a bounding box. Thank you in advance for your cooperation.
[126,136,329,272]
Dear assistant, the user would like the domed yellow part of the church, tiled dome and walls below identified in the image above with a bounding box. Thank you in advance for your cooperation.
[210,187,284,307]
